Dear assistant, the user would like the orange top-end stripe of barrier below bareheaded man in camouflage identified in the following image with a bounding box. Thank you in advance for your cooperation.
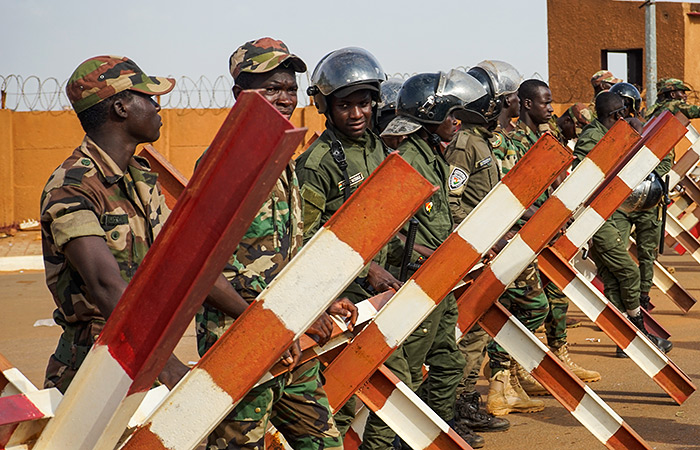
[502,133,573,207]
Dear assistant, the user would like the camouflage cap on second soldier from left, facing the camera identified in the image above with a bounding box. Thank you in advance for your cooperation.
[229,37,306,80]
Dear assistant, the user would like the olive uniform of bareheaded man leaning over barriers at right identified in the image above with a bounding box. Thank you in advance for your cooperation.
[573,119,640,311]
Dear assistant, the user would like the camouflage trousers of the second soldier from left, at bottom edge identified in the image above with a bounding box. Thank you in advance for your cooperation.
[207,360,343,450]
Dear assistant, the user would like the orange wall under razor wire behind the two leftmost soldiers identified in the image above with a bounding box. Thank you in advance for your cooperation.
[0,106,324,225]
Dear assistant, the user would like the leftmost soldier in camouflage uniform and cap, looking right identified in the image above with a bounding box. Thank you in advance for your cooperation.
[41,56,247,392]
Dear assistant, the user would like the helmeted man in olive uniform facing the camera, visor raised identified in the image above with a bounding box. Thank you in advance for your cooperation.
[296,47,401,442]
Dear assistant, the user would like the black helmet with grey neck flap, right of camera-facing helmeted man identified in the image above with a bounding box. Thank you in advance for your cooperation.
[383,69,486,136]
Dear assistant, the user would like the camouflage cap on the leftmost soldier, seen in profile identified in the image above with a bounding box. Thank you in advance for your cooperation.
[66,56,175,113]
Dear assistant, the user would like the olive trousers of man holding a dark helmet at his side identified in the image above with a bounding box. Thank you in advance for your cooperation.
[612,207,662,292]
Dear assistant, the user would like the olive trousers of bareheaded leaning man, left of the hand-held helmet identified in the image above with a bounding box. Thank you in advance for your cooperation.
[590,219,640,312]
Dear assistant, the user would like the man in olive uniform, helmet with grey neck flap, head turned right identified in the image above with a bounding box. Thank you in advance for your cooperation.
[380,70,490,448]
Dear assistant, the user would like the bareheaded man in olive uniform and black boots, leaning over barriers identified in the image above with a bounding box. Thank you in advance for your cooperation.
[573,92,672,357]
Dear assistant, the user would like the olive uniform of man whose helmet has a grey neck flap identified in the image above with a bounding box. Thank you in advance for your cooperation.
[360,133,465,449]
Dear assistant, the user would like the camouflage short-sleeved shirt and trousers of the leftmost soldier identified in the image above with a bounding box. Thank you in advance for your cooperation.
[41,136,170,392]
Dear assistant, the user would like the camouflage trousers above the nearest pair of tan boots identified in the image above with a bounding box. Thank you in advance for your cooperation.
[487,261,549,374]
